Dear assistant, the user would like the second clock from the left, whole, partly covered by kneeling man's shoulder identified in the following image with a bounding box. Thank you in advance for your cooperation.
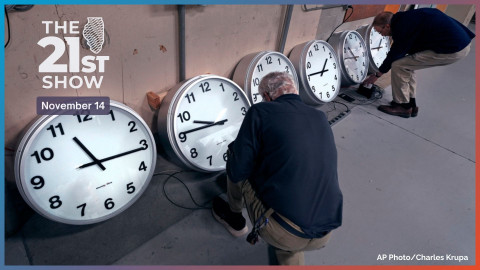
[158,75,250,172]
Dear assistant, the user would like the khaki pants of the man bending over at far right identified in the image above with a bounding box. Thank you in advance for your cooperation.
[391,44,470,103]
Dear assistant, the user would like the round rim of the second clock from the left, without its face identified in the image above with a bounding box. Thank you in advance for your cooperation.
[165,74,251,173]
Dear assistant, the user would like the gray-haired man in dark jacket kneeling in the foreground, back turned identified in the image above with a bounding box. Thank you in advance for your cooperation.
[212,72,343,265]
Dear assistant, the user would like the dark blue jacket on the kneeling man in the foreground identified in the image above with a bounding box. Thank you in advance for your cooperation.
[227,94,343,238]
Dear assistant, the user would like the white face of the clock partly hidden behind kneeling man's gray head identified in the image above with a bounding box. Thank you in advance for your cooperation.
[245,51,298,104]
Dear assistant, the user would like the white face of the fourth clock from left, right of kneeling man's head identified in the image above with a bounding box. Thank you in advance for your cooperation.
[301,40,341,102]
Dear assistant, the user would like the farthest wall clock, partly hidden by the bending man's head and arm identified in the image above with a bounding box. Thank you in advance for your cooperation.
[357,25,390,73]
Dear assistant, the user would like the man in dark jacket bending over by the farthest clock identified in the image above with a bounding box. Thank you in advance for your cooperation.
[363,8,475,118]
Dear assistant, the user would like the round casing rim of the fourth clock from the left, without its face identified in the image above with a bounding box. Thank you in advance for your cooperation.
[290,39,342,105]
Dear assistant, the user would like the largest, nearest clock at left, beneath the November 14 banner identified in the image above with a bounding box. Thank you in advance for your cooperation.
[15,101,157,224]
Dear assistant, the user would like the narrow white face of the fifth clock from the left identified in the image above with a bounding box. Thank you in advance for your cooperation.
[342,31,368,83]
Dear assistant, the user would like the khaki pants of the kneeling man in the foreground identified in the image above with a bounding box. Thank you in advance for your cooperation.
[227,178,331,265]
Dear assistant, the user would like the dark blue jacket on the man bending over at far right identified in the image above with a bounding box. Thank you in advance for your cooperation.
[379,8,475,73]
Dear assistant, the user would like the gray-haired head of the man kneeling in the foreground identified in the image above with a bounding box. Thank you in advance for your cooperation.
[258,72,298,99]
